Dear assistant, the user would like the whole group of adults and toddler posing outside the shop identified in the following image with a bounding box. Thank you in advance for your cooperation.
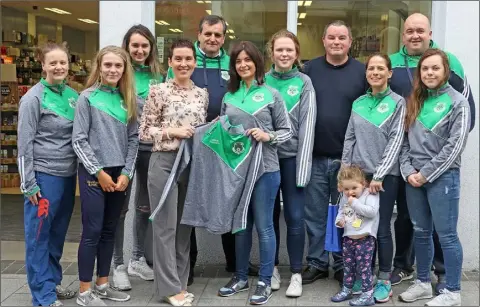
[18,10,475,306]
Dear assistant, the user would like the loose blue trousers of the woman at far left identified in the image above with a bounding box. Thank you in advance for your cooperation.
[24,172,76,306]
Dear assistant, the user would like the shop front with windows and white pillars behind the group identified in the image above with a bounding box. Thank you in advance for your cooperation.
[1,0,479,268]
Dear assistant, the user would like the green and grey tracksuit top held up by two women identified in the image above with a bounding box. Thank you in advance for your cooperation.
[153,116,264,234]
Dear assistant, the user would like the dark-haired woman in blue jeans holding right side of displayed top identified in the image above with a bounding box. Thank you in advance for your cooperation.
[218,41,292,305]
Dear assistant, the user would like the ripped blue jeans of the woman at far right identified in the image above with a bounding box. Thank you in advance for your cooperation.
[406,169,463,291]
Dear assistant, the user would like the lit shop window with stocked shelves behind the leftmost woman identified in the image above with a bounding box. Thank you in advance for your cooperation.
[0,1,99,194]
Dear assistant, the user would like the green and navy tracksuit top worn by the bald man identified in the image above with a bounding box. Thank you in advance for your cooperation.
[390,40,475,131]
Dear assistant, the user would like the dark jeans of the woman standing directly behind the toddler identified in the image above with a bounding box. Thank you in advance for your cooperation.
[367,175,403,280]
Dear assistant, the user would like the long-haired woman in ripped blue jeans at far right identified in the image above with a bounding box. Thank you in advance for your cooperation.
[399,49,470,306]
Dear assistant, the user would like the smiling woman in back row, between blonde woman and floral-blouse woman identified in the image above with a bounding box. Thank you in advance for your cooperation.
[113,25,164,290]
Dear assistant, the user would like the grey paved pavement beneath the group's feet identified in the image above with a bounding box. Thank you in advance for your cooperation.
[1,260,480,306]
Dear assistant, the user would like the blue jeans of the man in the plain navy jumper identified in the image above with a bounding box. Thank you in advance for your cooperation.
[305,157,343,272]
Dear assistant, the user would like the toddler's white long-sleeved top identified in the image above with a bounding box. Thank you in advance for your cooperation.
[335,189,380,238]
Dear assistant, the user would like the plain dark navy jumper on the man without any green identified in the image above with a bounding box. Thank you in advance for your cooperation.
[304,56,368,159]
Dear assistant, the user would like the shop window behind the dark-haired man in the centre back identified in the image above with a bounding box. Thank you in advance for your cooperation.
[155,1,287,68]
